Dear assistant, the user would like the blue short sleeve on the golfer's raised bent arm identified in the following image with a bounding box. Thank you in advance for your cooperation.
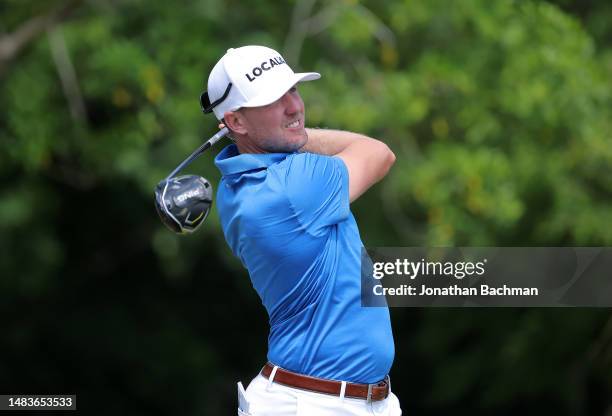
[285,153,350,235]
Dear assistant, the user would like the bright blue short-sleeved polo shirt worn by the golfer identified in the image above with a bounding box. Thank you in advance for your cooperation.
[215,144,394,383]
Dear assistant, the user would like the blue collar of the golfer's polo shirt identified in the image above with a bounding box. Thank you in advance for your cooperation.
[215,144,290,176]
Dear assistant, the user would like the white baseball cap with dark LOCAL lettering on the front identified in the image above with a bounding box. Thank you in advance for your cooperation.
[200,45,321,120]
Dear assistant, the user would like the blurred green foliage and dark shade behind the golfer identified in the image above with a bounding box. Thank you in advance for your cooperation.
[0,0,612,415]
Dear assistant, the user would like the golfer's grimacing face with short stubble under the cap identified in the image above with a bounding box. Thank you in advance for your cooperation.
[240,86,308,153]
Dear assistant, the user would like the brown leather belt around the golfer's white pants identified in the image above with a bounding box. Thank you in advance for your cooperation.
[261,363,389,402]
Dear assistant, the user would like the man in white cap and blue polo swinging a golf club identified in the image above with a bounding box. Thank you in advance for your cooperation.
[203,46,401,416]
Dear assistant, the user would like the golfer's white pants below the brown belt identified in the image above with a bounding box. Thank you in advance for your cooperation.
[238,374,402,416]
